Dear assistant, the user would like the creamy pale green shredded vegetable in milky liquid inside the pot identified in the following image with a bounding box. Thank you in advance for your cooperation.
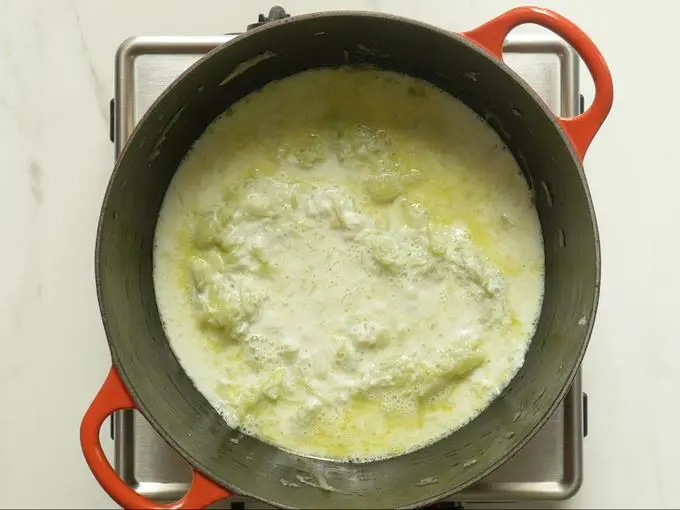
[154,65,543,461]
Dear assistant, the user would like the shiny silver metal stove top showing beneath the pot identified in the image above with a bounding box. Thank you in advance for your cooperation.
[112,35,583,508]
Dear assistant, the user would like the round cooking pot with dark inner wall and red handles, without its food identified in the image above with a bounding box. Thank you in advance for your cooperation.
[81,8,613,509]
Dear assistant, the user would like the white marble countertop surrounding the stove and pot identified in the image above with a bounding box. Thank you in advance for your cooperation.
[0,0,680,508]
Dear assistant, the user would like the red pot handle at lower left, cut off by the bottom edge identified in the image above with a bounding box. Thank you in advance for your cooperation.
[80,367,231,509]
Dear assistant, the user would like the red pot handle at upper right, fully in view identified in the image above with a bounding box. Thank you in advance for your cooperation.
[462,7,614,159]
